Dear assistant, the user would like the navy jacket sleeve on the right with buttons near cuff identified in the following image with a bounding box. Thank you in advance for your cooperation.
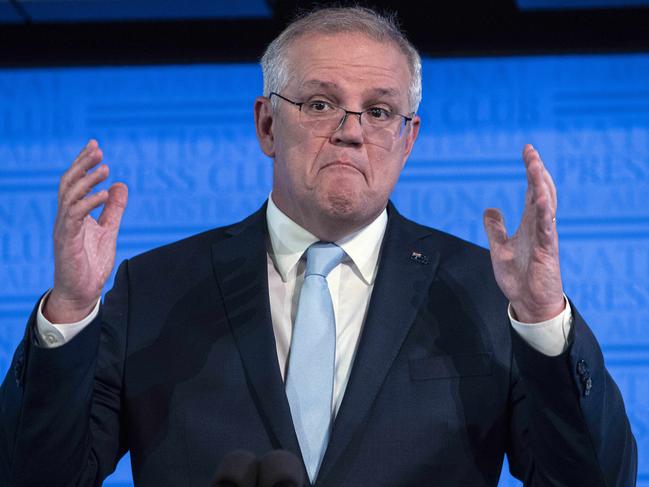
[508,303,638,487]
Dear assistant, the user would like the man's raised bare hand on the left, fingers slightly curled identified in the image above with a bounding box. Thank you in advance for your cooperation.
[43,140,128,323]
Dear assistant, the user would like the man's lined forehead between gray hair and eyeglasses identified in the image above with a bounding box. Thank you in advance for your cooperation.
[288,33,410,101]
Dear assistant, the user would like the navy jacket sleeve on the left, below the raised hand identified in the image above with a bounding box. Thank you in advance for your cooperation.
[0,261,128,487]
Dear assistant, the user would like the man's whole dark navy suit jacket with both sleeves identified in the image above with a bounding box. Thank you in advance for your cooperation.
[0,203,637,487]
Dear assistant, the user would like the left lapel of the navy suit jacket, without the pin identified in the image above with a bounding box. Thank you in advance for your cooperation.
[212,205,300,456]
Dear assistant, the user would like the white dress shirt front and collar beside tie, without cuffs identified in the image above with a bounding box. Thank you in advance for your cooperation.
[266,197,388,414]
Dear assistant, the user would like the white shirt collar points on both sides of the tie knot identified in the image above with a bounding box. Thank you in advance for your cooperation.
[266,194,388,284]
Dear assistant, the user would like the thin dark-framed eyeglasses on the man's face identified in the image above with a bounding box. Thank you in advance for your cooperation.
[268,92,412,150]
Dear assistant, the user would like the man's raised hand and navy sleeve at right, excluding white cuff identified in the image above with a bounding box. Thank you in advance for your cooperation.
[484,145,637,486]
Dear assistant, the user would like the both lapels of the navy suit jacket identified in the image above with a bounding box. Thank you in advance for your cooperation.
[212,206,439,485]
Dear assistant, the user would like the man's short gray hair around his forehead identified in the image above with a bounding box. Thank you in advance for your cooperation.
[261,7,421,112]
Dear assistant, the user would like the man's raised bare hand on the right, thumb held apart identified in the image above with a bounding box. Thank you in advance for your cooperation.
[483,144,565,323]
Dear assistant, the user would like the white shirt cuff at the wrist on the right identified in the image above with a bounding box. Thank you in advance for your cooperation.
[507,295,573,357]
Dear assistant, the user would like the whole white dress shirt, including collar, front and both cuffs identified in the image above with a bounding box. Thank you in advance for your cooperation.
[36,195,572,414]
